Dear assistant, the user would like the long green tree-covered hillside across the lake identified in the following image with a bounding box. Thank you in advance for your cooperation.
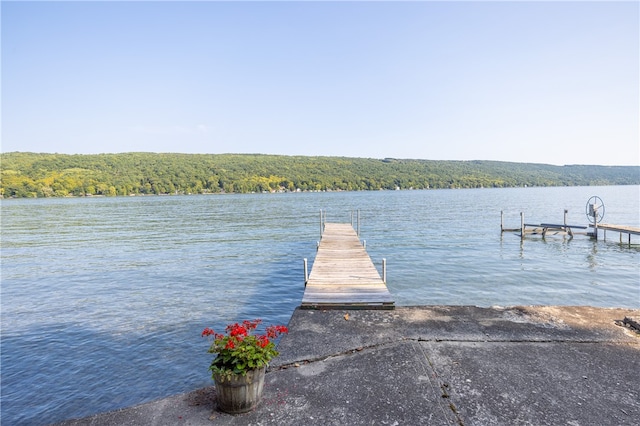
[0,152,640,198]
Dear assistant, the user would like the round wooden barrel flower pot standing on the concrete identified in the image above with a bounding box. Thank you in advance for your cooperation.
[213,367,266,414]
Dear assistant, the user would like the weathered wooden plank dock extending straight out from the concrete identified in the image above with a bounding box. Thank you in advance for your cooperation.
[300,223,394,309]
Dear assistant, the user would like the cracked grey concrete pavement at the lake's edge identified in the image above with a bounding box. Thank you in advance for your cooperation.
[57,306,640,426]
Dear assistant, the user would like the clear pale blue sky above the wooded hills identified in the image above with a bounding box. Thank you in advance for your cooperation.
[1,1,640,165]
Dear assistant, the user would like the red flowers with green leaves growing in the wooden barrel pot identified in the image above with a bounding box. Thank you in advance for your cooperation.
[202,319,289,380]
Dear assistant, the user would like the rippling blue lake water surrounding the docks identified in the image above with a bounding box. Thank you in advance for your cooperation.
[1,186,640,425]
